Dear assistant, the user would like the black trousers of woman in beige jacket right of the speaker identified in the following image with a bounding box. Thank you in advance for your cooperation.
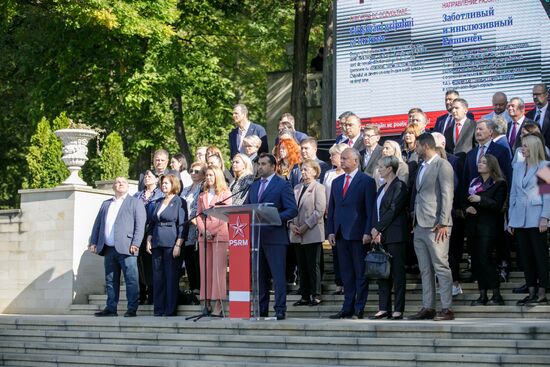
[294,242,321,299]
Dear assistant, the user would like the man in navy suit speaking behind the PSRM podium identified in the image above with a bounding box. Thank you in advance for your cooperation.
[246,153,298,320]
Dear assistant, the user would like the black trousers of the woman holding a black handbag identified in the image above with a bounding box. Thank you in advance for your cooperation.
[378,242,407,313]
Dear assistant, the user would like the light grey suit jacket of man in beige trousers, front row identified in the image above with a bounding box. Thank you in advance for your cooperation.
[411,155,454,228]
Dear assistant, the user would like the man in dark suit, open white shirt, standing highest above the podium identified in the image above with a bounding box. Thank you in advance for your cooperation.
[229,104,268,158]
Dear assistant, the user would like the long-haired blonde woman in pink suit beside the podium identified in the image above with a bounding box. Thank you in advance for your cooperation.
[197,167,231,315]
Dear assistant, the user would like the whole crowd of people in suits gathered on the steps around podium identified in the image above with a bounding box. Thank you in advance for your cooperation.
[89,84,550,321]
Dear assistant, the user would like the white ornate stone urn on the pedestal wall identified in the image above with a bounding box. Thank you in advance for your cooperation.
[54,129,98,186]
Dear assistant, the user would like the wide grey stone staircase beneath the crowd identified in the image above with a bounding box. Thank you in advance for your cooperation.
[0,244,550,367]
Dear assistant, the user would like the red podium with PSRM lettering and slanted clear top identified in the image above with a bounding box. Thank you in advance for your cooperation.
[204,203,281,319]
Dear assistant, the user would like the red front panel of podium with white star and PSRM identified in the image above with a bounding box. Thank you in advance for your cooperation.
[228,213,252,319]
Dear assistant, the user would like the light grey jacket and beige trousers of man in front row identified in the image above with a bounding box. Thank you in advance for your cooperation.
[413,155,454,309]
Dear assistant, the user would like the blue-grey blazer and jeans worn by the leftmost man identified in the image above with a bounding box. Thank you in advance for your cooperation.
[90,195,147,313]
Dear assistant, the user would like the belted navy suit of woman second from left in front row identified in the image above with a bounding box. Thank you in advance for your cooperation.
[149,195,188,316]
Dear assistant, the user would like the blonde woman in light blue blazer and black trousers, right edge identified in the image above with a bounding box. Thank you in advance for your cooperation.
[508,135,550,306]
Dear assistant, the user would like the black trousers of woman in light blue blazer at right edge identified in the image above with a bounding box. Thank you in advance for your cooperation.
[514,227,549,289]
